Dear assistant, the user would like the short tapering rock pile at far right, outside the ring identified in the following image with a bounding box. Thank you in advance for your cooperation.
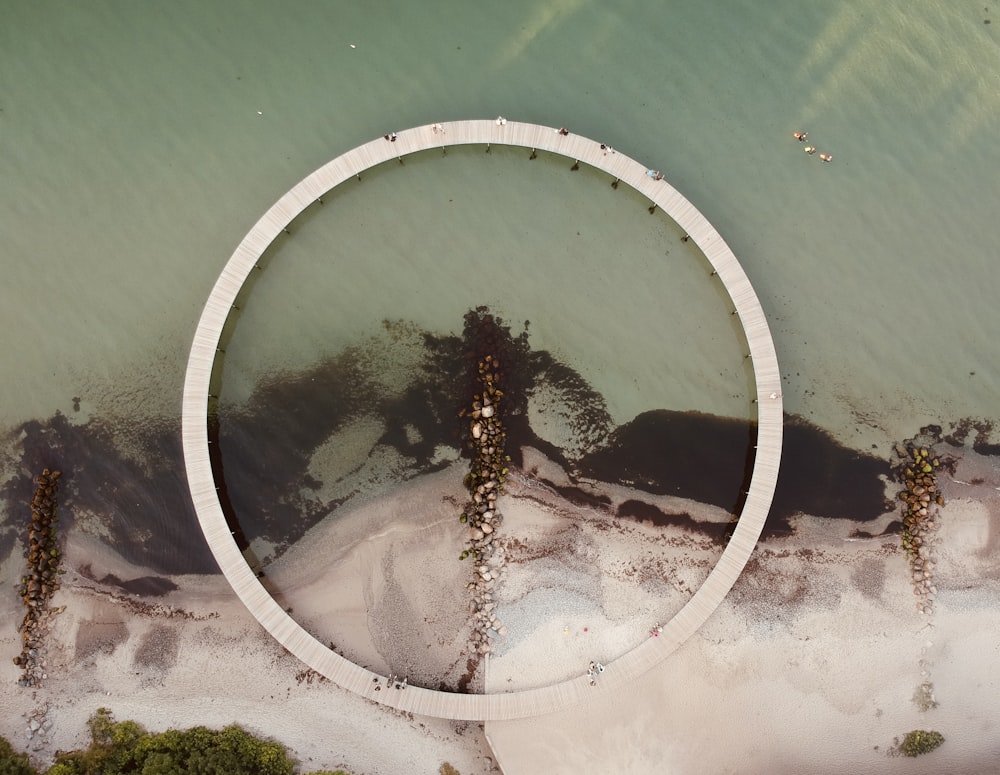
[897,446,944,614]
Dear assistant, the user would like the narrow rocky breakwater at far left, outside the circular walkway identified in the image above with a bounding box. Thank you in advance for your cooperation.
[14,468,62,687]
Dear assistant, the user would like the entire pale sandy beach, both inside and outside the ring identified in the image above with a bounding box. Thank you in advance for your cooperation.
[0,440,1000,773]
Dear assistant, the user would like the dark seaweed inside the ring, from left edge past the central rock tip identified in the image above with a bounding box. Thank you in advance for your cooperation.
[210,307,610,548]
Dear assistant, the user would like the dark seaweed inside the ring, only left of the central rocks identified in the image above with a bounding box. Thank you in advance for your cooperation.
[210,324,458,548]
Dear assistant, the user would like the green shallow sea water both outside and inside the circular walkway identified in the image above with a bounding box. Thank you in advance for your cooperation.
[0,0,1000,596]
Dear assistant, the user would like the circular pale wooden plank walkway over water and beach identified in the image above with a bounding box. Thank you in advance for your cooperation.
[182,119,782,720]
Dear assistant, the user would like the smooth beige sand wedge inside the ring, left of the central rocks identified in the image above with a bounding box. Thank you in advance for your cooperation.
[265,464,471,688]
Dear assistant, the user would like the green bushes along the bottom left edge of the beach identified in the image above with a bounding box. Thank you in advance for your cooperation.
[0,708,348,775]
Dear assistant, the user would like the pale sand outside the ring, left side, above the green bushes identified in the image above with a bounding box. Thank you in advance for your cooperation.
[0,535,500,775]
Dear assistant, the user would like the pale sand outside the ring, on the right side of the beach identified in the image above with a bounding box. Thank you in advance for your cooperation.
[487,453,1000,774]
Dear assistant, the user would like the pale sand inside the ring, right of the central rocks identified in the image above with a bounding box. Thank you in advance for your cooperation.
[488,454,729,692]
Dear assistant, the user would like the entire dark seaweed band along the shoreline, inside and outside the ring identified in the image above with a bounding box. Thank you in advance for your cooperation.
[0,310,952,594]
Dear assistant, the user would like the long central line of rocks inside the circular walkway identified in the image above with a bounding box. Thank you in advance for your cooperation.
[459,355,510,655]
